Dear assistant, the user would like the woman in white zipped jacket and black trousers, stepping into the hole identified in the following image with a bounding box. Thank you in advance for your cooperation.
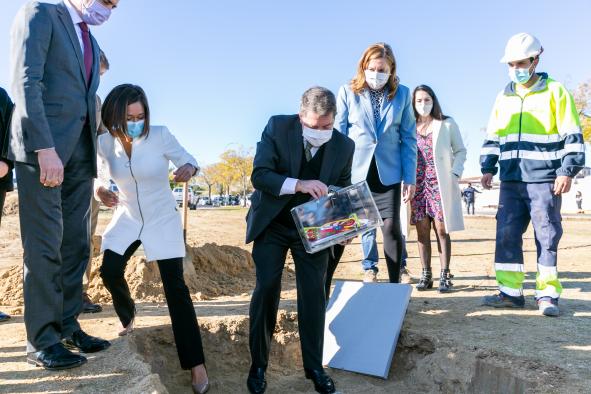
[95,84,209,393]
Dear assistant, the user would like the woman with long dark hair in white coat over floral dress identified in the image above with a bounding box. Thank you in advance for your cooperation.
[410,85,466,292]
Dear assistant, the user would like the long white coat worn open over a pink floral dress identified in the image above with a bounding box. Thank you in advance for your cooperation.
[433,118,466,233]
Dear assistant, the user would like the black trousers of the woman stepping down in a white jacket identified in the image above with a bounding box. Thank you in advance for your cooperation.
[101,241,205,369]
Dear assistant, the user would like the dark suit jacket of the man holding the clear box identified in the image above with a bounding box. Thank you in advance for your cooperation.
[246,115,355,243]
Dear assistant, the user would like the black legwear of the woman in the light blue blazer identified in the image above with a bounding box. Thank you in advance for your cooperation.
[325,183,404,299]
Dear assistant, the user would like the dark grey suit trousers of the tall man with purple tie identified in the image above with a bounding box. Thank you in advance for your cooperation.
[15,126,96,352]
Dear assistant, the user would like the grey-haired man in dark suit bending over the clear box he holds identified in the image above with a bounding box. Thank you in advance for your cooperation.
[246,87,354,393]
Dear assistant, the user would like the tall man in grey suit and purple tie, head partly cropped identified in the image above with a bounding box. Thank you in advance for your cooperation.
[8,0,119,370]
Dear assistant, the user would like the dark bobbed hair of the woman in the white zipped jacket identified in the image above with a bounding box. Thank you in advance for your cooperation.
[102,83,150,137]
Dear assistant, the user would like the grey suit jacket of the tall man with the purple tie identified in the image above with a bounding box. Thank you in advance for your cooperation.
[9,1,99,174]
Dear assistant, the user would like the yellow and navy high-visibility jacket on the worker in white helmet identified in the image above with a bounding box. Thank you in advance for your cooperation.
[480,73,585,183]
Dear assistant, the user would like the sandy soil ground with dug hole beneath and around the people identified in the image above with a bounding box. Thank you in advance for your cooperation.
[0,202,591,393]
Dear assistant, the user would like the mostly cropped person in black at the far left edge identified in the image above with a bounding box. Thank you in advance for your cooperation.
[0,88,14,322]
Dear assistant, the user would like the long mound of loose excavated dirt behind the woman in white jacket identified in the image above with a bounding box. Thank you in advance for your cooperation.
[0,240,254,306]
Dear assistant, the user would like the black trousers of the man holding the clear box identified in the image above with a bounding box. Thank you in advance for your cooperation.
[249,222,328,369]
